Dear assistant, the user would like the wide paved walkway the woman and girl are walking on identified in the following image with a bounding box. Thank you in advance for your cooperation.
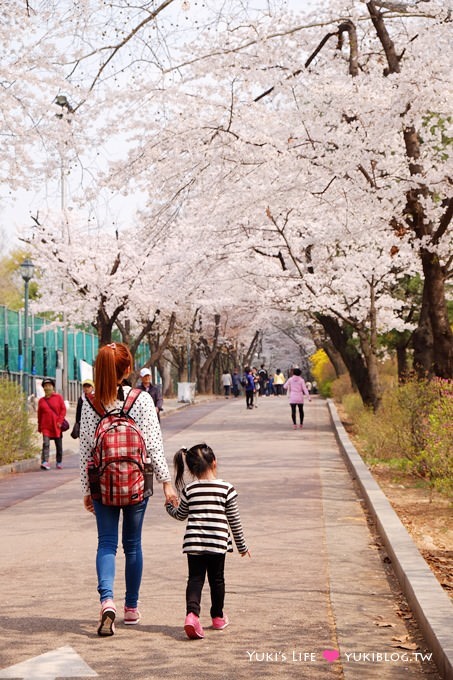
[0,398,439,680]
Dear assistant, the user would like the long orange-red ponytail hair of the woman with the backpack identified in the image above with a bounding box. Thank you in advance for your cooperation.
[94,342,133,408]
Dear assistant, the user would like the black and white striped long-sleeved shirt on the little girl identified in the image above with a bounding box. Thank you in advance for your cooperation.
[166,479,247,554]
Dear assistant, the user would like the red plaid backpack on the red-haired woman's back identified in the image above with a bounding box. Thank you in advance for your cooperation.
[88,389,152,506]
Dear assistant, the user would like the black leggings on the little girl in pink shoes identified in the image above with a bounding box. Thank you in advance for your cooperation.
[186,553,225,619]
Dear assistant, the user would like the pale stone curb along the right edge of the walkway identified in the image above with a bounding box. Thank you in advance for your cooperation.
[327,399,453,680]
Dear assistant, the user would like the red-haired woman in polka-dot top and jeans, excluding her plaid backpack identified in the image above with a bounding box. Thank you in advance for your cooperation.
[80,342,177,636]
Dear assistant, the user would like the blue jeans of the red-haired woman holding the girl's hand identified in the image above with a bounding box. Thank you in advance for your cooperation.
[93,498,148,607]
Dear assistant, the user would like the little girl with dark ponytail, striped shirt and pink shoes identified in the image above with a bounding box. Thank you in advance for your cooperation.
[165,444,251,639]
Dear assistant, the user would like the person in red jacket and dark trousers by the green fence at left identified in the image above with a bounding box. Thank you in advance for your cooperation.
[38,378,66,470]
